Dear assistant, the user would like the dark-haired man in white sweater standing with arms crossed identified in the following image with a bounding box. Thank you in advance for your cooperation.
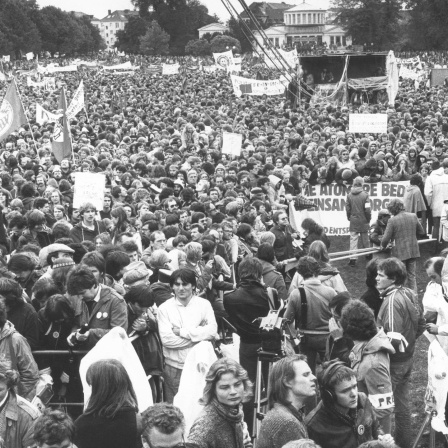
[157,268,218,403]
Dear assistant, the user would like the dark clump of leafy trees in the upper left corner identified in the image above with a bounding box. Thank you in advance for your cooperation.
[0,0,105,58]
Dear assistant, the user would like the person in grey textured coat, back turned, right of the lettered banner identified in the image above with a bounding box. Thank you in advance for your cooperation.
[381,200,426,294]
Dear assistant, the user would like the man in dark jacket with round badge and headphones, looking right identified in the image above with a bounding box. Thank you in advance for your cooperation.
[305,361,393,448]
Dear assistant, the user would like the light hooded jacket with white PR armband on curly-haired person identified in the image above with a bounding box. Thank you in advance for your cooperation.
[350,329,395,419]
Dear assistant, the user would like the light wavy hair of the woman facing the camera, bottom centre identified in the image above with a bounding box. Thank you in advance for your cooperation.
[199,358,253,406]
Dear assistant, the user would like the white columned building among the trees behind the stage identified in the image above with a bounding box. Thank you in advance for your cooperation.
[254,0,352,49]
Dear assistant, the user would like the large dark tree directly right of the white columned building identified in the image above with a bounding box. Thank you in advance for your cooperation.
[334,0,401,50]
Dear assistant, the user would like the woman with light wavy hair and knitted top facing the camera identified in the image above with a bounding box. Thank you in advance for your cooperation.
[188,358,252,448]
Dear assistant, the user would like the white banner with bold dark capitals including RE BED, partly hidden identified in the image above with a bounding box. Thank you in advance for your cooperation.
[295,181,409,236]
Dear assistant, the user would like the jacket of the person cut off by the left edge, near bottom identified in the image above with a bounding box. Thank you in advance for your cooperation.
[0,321,39,401]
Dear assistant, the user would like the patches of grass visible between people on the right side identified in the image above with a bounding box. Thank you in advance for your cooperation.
[330,236,444,448]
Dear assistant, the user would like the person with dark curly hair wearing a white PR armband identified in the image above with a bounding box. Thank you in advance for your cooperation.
[340,300,395,434]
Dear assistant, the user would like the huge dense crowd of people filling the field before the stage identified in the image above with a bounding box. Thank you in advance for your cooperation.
[0,49,448,448]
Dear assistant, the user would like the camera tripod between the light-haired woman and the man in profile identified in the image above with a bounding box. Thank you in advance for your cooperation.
[252,348,281,438]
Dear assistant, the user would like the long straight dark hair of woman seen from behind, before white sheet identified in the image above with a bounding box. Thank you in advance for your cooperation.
[84,359,138,419]
